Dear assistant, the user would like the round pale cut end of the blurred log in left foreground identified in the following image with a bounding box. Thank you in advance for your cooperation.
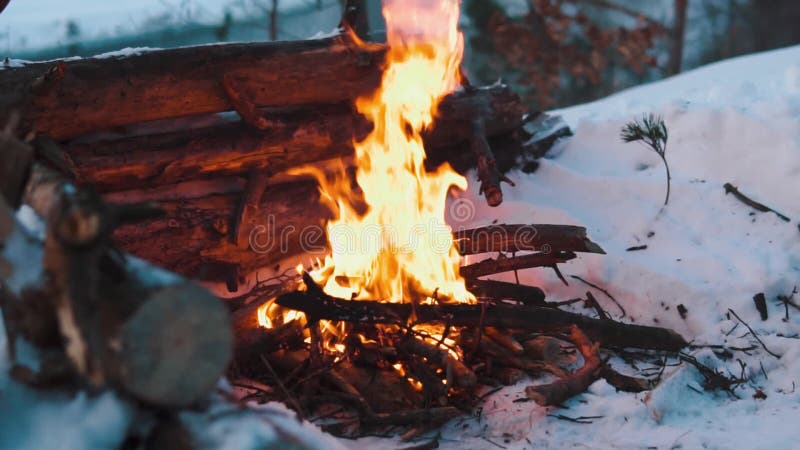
[119,284,233,407]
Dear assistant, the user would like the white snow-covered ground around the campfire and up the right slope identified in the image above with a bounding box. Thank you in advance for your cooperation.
[0,42,800,449]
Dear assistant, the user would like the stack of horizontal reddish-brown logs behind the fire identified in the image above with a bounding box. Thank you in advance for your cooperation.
[0,34,569,291]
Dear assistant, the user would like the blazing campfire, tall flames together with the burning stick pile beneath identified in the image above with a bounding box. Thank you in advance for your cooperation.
[223,1,685,437]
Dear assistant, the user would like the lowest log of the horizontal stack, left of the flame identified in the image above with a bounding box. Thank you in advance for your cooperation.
[114,182,330,286]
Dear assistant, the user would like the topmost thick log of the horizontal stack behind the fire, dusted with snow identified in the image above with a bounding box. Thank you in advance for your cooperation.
[0,36,385,141]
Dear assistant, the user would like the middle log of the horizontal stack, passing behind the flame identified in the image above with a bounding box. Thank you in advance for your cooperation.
[64,85,524,191]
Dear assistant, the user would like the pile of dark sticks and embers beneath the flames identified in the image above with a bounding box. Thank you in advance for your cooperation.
[230,221,687,437]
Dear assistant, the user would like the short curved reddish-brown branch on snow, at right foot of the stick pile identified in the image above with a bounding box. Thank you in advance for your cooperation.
[525,325,601,406]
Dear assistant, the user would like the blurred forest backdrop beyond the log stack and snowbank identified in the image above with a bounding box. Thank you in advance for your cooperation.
[0,0,800,109]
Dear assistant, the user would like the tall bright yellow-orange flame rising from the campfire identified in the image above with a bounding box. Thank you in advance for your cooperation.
[300,0,474,302]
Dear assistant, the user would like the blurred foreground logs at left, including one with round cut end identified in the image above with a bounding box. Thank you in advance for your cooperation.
[0,135,232,407]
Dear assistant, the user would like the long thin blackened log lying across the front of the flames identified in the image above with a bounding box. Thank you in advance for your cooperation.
[276,290,687,351]
